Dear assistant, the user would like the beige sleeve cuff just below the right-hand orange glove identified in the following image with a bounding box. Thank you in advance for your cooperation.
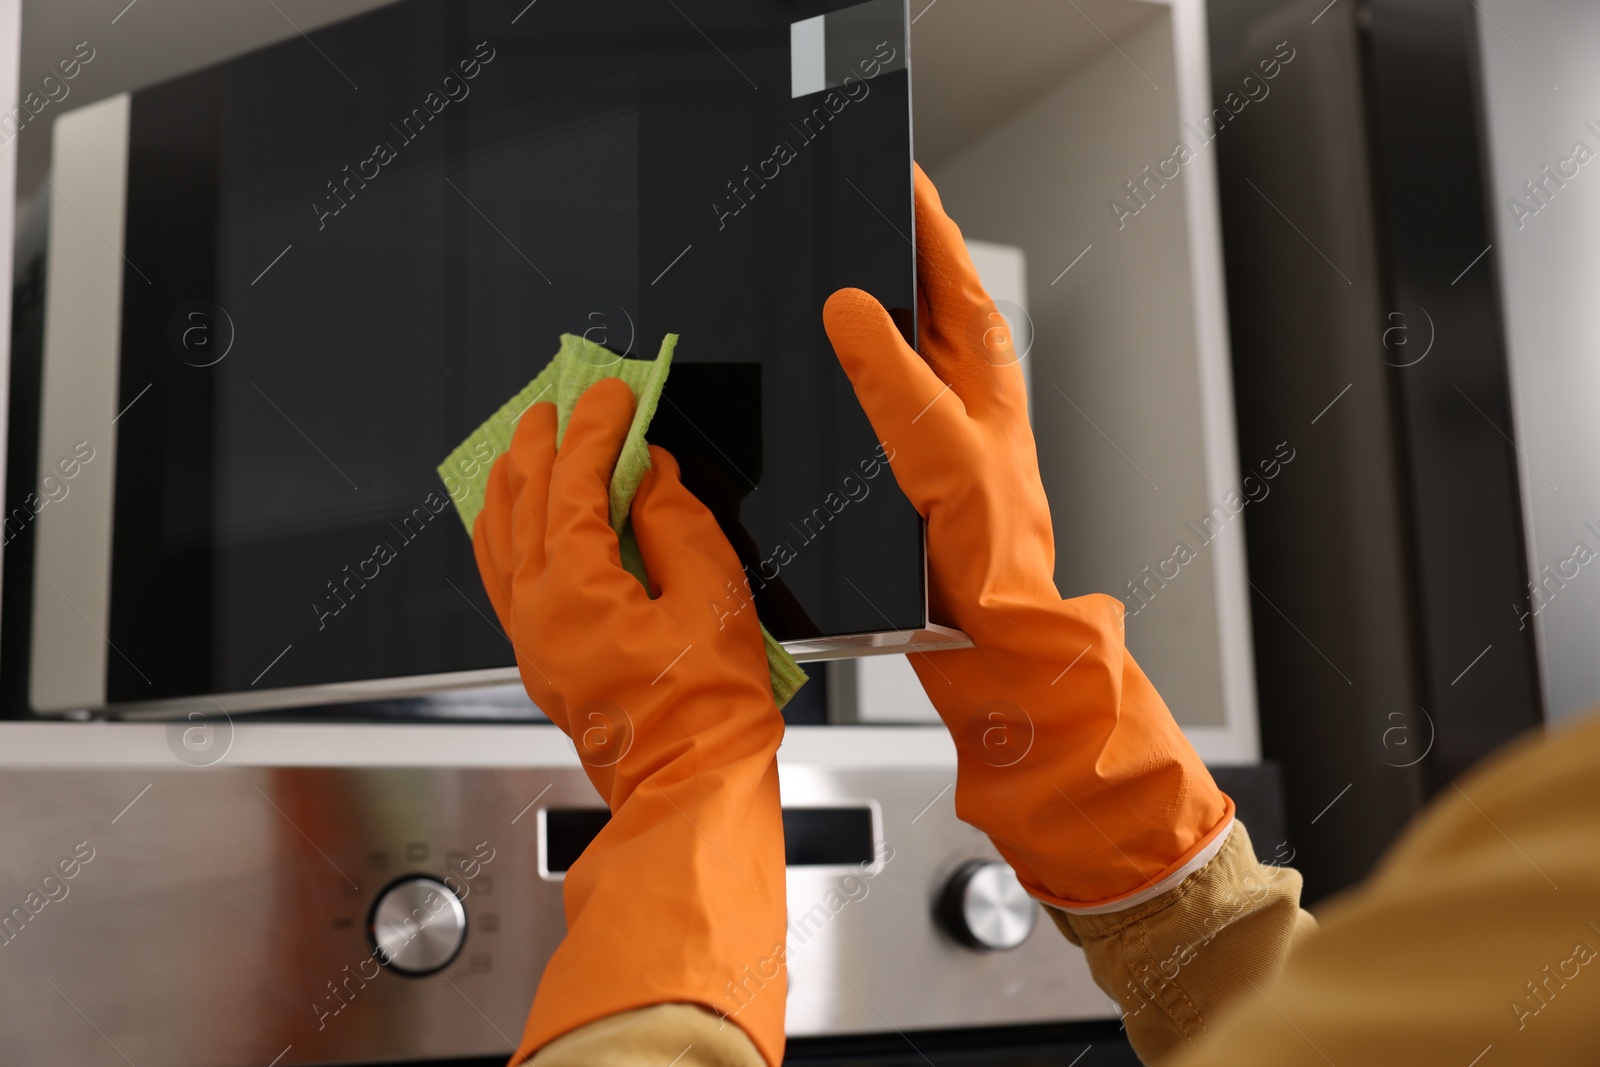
[1046,822,1317,1064]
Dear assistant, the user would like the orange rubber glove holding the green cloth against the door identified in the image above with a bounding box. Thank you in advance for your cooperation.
[472,379,787,1067]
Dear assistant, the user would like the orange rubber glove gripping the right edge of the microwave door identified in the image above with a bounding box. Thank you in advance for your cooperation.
[822,168,1234,912]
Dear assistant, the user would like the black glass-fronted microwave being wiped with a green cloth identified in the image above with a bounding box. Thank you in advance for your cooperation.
[5,0,966,717]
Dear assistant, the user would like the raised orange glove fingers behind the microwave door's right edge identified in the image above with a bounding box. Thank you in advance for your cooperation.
[914,166,1027,413]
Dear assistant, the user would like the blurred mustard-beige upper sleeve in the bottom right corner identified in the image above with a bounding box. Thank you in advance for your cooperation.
[1163,717,1600,1067]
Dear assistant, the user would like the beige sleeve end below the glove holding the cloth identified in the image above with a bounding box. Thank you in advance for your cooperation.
[526,1005,766,1067]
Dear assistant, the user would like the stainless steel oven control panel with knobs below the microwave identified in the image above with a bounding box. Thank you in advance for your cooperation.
[0,723,1114,1067]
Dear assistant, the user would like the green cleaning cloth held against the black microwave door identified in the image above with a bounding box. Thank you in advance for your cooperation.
[438,333,806,707]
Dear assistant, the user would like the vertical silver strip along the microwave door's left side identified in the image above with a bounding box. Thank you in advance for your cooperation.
[29,93,131,712]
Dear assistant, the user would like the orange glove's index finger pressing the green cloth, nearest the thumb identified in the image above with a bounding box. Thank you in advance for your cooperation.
[544,378,643,611]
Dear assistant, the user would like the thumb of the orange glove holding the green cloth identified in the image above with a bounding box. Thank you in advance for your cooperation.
[634,445,755,625]
